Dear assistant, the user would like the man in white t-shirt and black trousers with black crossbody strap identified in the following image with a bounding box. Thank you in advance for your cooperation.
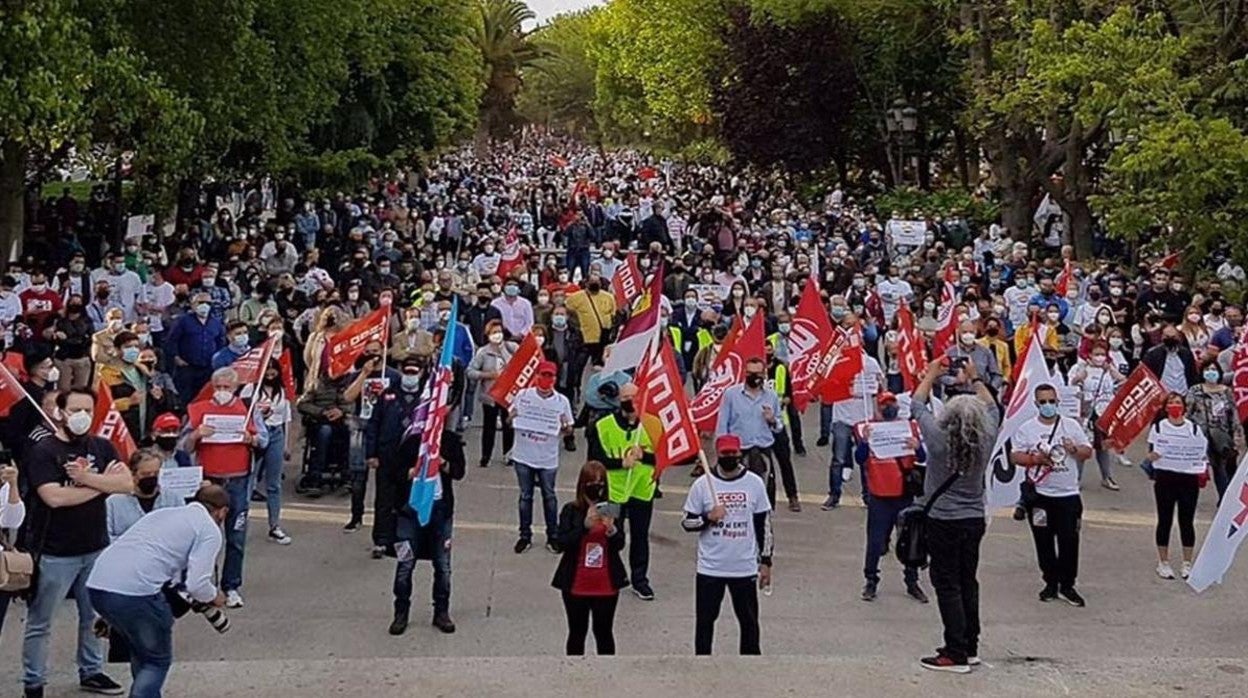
[1010,383,1092,608]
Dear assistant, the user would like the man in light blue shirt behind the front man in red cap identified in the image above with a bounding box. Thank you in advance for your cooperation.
[715,358,784,506]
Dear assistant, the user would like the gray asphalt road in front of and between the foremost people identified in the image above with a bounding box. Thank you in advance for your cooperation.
[0,415,1248,697]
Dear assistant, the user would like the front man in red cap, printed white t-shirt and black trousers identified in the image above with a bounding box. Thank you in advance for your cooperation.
[681,433,771,654]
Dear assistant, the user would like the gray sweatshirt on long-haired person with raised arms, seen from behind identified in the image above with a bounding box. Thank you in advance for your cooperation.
[910,401,998,521]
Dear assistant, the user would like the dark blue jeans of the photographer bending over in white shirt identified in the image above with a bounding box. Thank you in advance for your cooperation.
[91,589,173,698]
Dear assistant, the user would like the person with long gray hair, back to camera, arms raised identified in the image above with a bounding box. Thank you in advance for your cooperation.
[911,358,998,674]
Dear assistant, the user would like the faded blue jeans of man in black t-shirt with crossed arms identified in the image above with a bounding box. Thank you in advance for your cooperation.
[21,552,104,687]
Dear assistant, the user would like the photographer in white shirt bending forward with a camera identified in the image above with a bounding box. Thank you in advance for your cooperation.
[86,484,230,698]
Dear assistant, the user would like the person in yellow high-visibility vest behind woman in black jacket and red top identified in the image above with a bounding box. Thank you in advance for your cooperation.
[589,383,658,601]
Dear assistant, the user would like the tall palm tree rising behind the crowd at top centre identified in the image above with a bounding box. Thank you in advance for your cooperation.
[473,0,543,142]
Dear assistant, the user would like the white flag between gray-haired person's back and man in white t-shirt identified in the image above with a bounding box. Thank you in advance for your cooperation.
[983,328,1062,508]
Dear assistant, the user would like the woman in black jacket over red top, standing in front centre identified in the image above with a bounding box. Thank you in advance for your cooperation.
[550,461,628,656]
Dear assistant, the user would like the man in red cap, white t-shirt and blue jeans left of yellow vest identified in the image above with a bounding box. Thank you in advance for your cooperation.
[510,361,573,553]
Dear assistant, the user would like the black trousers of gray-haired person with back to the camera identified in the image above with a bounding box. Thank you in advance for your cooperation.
[927,516,986,661]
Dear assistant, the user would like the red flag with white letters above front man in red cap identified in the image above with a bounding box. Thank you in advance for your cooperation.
[636,333,700,479]
